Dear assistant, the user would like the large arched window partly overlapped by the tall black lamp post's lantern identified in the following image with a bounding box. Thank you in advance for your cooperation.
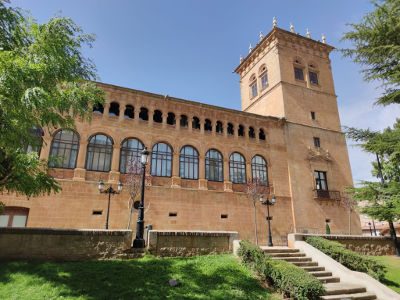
[119,138,144,173]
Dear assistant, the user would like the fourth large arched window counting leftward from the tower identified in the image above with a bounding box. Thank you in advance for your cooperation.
[179,146,199,179]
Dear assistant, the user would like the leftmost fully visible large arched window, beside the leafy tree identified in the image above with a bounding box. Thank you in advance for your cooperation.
[49,129,79,169]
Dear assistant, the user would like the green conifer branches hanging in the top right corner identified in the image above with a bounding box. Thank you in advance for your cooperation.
[343,0,400,105]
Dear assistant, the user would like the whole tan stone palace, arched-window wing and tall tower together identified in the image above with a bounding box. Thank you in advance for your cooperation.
[0,26,361,244]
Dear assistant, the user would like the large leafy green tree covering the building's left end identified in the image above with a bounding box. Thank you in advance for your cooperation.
[0,0,104,196]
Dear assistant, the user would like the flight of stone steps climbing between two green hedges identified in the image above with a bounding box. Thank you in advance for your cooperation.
[261,247,377,300]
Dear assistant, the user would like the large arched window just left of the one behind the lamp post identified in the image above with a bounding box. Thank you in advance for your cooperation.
[86,134,113,172]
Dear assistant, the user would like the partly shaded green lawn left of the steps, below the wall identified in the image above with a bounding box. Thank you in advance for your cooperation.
[0,255,276,300]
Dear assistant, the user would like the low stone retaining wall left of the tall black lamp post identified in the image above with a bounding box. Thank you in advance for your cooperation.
[0,228,132,261]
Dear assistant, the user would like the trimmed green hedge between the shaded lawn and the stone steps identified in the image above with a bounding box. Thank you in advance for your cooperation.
[238,241,325,300]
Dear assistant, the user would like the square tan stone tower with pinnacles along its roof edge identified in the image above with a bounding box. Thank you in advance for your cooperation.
[235,21,361,233]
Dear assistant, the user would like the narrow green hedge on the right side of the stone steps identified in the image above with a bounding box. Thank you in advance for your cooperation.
[306,237,385,281]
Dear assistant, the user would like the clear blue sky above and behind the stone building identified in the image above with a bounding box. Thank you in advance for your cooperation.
[12,0,400,183]
